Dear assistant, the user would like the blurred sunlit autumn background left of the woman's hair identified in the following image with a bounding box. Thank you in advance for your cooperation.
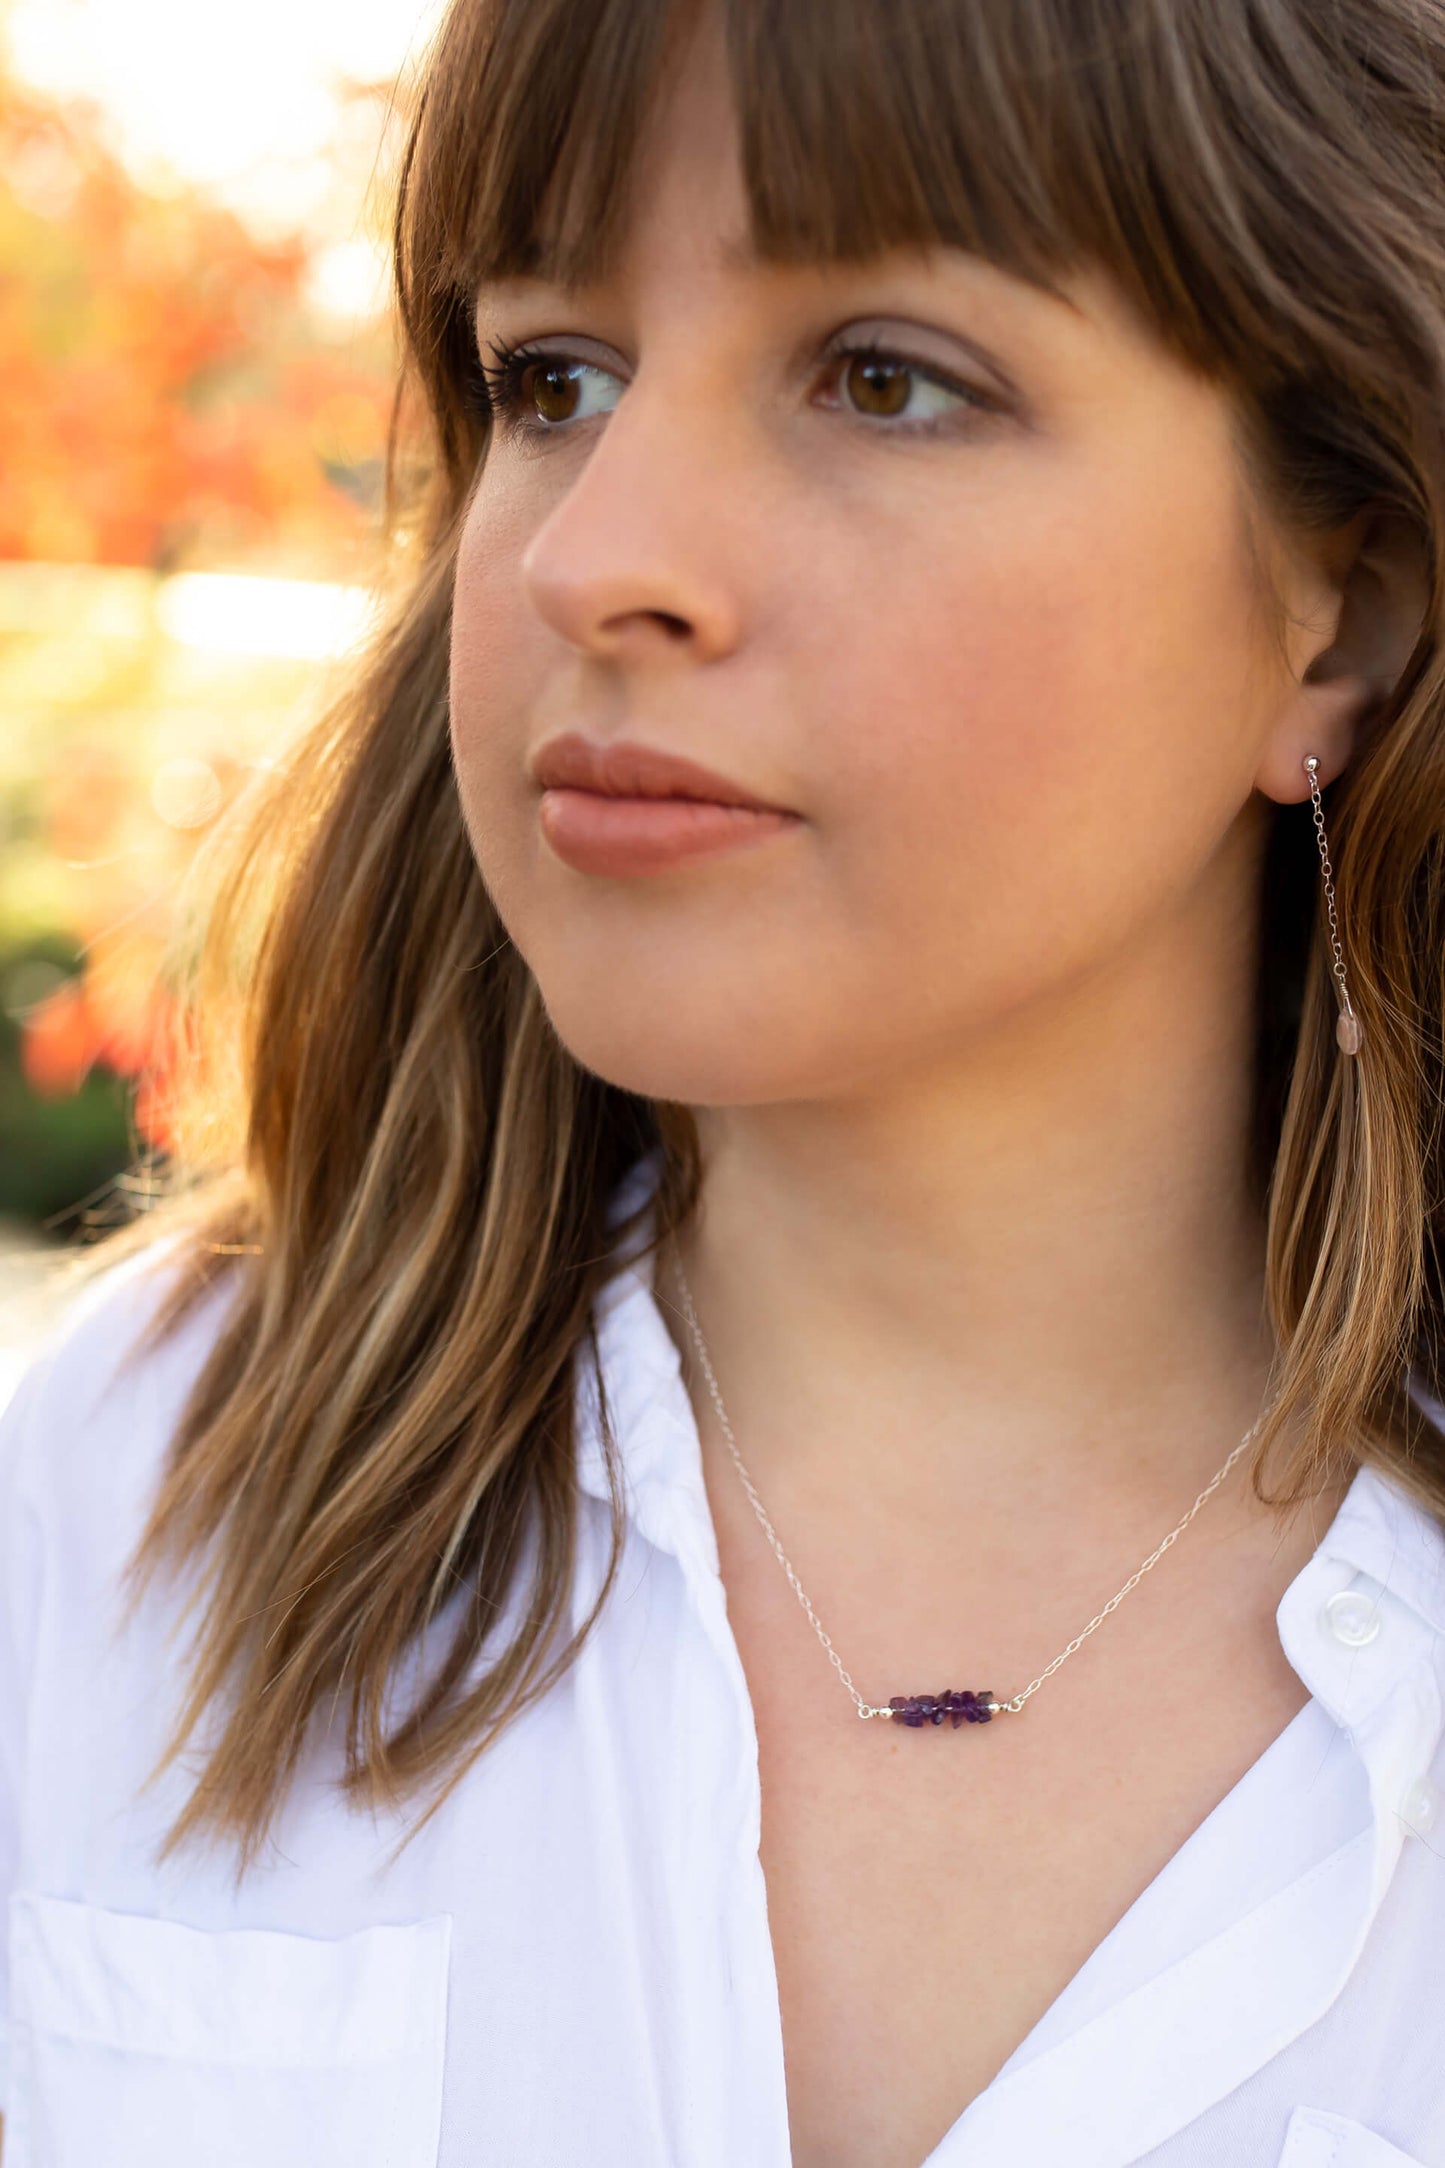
[0,0,440,1403]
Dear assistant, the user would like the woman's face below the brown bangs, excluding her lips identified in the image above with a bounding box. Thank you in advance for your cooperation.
[451,8,1322,1106]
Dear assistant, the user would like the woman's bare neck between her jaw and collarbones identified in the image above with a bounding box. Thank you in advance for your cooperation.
[659,906,1274,1524]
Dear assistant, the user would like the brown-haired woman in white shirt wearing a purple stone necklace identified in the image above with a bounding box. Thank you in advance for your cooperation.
[0,0,1445,2168]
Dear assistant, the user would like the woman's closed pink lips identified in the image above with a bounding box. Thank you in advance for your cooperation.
[531,731,799,878]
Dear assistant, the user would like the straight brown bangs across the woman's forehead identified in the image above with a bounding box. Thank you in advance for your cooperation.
[407,0,1256,366]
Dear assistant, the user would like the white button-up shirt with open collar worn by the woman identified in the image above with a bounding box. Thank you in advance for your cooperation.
[0,1160,1445,2168]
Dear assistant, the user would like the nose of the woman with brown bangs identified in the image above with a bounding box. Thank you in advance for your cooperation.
[522,373,758,661]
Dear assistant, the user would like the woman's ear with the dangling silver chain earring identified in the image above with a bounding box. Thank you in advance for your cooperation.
[1254,509,1430,804]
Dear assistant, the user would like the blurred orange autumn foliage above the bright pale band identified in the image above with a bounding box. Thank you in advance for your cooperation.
[0,80,390,568]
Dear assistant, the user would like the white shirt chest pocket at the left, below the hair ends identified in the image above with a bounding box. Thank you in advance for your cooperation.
[4,1890,451,2168]
